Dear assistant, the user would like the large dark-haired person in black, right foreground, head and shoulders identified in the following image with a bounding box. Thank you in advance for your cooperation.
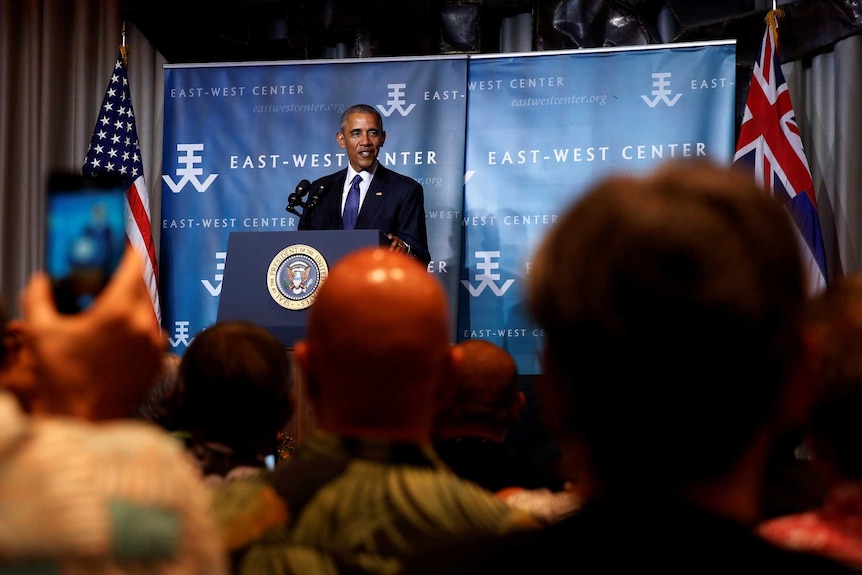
[432,160,846,574]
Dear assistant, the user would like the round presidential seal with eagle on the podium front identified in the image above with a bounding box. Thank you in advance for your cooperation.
[266,244,329,310]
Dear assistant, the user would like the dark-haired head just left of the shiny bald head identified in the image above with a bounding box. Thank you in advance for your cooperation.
[179,320,293,485]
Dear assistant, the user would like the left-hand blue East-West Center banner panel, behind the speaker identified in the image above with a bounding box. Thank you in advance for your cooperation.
[160,56,467,348]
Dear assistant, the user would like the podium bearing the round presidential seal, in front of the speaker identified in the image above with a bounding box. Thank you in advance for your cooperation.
[217,230,381,446]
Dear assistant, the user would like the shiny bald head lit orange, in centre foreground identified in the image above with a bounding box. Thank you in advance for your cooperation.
[295,248,452,439]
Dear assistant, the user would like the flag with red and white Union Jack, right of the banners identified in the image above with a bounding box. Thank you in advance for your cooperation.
[733,11,828,293]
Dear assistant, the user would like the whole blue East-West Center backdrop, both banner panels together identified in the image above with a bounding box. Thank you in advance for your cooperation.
[160,41,736,374]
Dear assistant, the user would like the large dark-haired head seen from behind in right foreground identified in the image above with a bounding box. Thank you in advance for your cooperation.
[529,161,805,483]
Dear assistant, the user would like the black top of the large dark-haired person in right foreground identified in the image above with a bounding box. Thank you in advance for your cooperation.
[402,488,859,575]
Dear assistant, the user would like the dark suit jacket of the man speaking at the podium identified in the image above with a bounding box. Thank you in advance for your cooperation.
[297,164,431,265]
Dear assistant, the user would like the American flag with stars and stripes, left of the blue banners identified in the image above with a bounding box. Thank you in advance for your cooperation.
[82,46,161,324]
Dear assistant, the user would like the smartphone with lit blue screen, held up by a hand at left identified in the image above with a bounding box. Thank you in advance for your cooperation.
[45,173,126,314]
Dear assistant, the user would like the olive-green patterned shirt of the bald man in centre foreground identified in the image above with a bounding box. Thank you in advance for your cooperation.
[216,431,538,575]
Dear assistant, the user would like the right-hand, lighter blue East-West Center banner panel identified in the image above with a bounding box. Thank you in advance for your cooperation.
[458,42,736,374]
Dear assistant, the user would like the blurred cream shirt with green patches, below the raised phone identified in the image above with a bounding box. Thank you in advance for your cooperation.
[0,392,227,575]
